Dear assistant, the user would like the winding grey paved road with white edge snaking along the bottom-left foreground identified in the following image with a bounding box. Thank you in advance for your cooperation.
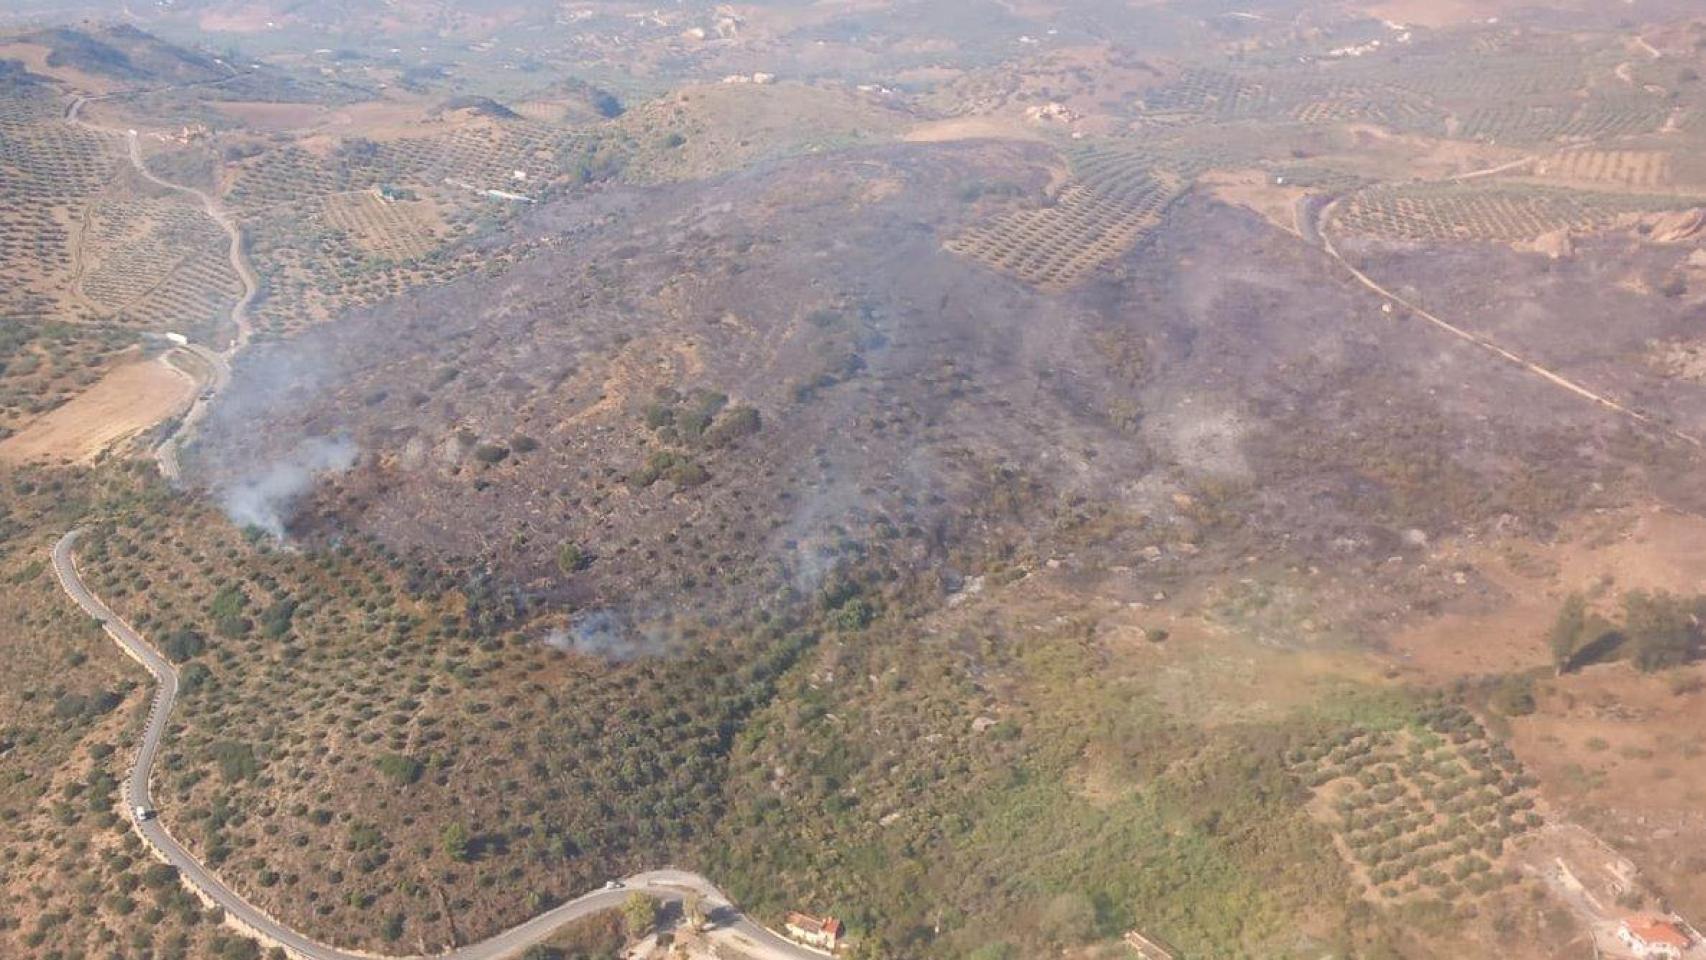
[53,530,826,960]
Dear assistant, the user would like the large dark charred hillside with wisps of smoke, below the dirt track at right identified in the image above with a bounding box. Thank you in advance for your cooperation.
[196,143,1685,644]
